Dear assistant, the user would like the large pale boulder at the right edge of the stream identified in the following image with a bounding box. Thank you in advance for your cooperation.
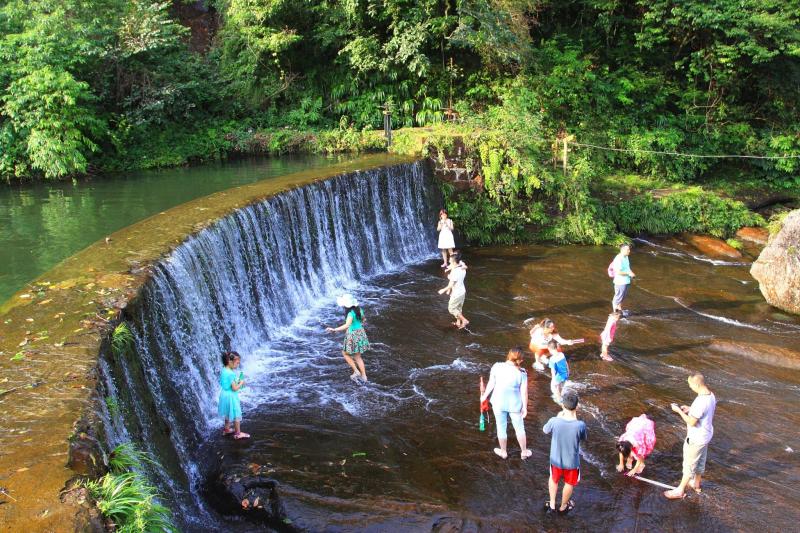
[750,209,800,314]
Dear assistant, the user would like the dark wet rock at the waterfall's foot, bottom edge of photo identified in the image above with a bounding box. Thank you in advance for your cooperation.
[207,464,291,529]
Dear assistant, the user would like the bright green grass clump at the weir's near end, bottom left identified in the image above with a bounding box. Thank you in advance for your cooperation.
[86,443,178,533]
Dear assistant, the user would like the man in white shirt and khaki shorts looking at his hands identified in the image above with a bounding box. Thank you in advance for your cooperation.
[664,374,717,500]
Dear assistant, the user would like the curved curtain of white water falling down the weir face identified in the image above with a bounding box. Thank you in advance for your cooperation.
[100,162,436,526]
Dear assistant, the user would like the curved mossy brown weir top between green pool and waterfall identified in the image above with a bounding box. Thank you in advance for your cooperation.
[0,154,412,531]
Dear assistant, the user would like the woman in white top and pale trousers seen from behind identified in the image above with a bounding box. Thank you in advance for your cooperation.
[481,348,533,460]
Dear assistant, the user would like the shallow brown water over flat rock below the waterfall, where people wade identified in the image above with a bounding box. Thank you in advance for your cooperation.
[216,242,800,531]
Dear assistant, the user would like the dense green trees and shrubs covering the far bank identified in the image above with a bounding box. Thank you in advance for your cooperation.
[0,0,800,185]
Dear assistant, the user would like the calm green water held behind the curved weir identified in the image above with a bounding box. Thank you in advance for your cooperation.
[0,156,344,302]
